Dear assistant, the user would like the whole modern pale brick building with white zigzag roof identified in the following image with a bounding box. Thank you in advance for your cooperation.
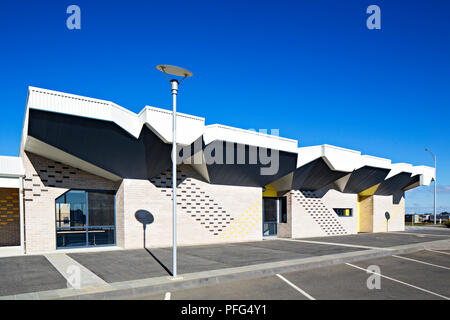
[0,87,435,254]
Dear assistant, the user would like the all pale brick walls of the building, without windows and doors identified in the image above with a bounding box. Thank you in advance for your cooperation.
[19,153,404,253]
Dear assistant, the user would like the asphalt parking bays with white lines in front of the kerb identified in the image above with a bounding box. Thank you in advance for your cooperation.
[143,250,450,300]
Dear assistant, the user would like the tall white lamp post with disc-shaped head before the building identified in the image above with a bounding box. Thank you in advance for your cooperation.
[156,65,193,280]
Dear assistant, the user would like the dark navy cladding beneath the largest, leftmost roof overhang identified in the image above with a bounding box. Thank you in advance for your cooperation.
[25,109,171,179]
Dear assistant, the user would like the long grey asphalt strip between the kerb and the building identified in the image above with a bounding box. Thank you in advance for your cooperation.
[65,229,450,283]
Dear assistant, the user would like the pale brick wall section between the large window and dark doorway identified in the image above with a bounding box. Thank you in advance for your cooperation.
[116,166,262,248]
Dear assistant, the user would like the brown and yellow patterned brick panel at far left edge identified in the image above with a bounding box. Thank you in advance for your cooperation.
[0,188,20,246]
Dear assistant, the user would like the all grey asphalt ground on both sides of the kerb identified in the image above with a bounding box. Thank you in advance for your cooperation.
[0,228,450,300]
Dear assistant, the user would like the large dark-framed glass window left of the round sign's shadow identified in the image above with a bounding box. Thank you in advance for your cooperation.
[55,190,115,248]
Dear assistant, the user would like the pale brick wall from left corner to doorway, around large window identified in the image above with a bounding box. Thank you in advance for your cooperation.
[24,153,262,253]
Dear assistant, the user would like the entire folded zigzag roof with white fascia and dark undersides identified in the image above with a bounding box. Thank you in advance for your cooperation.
[20,87,434,194]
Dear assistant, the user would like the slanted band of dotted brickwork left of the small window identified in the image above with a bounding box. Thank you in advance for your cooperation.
[292,190,348,236]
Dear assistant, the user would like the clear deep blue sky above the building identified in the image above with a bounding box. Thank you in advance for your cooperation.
[0,0,450,211]
